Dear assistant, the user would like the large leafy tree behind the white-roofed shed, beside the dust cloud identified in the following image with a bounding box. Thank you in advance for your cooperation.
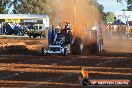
[10,0,48,14]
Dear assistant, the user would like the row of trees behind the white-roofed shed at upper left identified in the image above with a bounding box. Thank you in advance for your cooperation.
[0,0,48,14]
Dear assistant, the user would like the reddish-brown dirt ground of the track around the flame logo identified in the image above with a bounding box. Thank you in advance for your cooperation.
[0,38,132,88]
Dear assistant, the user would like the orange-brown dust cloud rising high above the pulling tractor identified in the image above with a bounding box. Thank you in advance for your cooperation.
[49,0,99,36]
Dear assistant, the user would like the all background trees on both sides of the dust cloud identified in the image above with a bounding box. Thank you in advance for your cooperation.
[0,0,132,22]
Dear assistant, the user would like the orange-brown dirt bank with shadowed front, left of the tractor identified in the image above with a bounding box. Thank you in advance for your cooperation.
[0,38,47,55]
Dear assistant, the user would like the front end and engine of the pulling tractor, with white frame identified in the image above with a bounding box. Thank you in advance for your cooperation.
[42,23,71,56]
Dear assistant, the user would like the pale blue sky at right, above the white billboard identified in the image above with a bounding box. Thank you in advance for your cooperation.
[97,0,127,13]
